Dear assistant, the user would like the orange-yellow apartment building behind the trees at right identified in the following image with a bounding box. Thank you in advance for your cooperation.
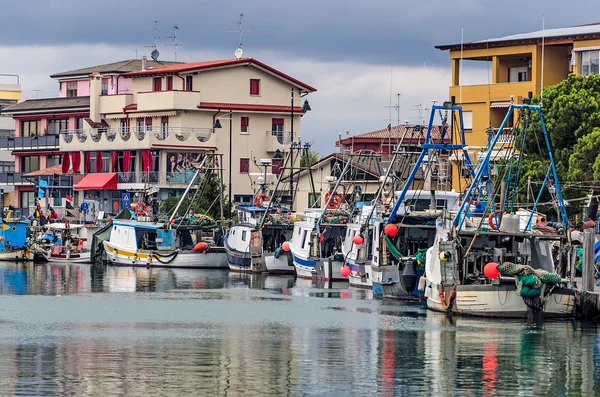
[436,24,600,189]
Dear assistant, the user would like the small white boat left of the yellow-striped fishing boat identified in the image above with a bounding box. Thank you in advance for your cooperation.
[40,222,91,263]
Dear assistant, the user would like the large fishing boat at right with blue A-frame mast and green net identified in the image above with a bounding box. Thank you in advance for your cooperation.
[418,99,576,318]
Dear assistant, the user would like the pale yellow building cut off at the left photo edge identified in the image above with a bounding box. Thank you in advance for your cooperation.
[0,74,21,207]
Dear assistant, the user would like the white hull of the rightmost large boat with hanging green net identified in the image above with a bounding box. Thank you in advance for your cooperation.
[427,284,576,319]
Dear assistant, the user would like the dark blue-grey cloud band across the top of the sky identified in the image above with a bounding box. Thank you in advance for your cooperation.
[0,0,596,65]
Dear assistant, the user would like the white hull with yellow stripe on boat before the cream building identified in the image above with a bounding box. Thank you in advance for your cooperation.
[102,241,227,269]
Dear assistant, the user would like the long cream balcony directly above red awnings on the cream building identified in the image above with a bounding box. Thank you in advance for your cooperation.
[60,126,217,152]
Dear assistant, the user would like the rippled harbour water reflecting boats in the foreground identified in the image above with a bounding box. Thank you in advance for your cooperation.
[0,263,600,397]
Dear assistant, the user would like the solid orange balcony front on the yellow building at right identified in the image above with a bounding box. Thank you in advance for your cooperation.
[450,81,536,103]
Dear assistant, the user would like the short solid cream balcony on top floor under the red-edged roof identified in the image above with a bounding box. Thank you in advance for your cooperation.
[137,90,200,112]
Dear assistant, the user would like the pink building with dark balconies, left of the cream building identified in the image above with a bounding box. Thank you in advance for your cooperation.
[0,59,174,214]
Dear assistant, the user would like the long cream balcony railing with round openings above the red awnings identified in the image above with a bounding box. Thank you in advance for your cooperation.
[61,126,213,150]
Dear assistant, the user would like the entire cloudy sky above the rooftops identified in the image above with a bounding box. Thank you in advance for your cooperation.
[0,0,597,154]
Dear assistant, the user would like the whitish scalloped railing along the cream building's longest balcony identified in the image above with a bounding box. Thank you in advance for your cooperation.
[60,126,212,144]
